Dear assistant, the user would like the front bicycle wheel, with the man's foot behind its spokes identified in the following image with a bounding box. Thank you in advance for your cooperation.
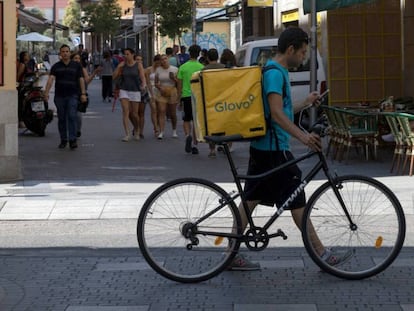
[302,175,405,280]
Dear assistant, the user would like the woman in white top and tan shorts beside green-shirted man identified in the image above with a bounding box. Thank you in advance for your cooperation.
[154,54,178,139]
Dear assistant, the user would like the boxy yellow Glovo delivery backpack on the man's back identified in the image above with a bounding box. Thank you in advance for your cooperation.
[191,66,266,141]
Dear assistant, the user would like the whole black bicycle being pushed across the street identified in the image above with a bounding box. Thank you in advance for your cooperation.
[137,136,406,283]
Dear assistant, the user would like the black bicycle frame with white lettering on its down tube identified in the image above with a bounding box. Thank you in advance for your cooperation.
[195,143,355,246]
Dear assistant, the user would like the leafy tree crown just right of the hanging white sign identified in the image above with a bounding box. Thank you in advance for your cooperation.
[145,0,192,40]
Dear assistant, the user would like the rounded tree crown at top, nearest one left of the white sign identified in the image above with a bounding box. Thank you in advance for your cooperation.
[82,0,122,39]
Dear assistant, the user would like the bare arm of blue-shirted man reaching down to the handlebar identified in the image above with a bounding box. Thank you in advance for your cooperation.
[267,93,321,151]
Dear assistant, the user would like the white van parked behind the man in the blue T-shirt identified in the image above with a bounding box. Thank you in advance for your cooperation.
[236,38,326,102]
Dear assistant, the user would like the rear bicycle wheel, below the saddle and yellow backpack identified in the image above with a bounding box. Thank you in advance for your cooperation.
[137,178,241,283]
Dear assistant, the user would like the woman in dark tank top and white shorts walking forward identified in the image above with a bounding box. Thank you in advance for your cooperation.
[112,48,146,142]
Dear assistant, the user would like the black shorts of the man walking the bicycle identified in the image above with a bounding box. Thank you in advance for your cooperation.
[244,148,306,209]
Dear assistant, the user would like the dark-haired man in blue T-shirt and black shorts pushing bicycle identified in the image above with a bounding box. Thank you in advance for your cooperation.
[229,27,352,270]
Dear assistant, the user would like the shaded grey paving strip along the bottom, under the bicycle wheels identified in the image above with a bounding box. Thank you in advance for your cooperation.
[0,248,414,311]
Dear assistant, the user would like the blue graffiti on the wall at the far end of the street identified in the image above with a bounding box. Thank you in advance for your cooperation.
[159,32,228,54]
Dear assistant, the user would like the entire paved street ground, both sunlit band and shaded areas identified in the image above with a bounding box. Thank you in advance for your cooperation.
[0,80,414,311]
